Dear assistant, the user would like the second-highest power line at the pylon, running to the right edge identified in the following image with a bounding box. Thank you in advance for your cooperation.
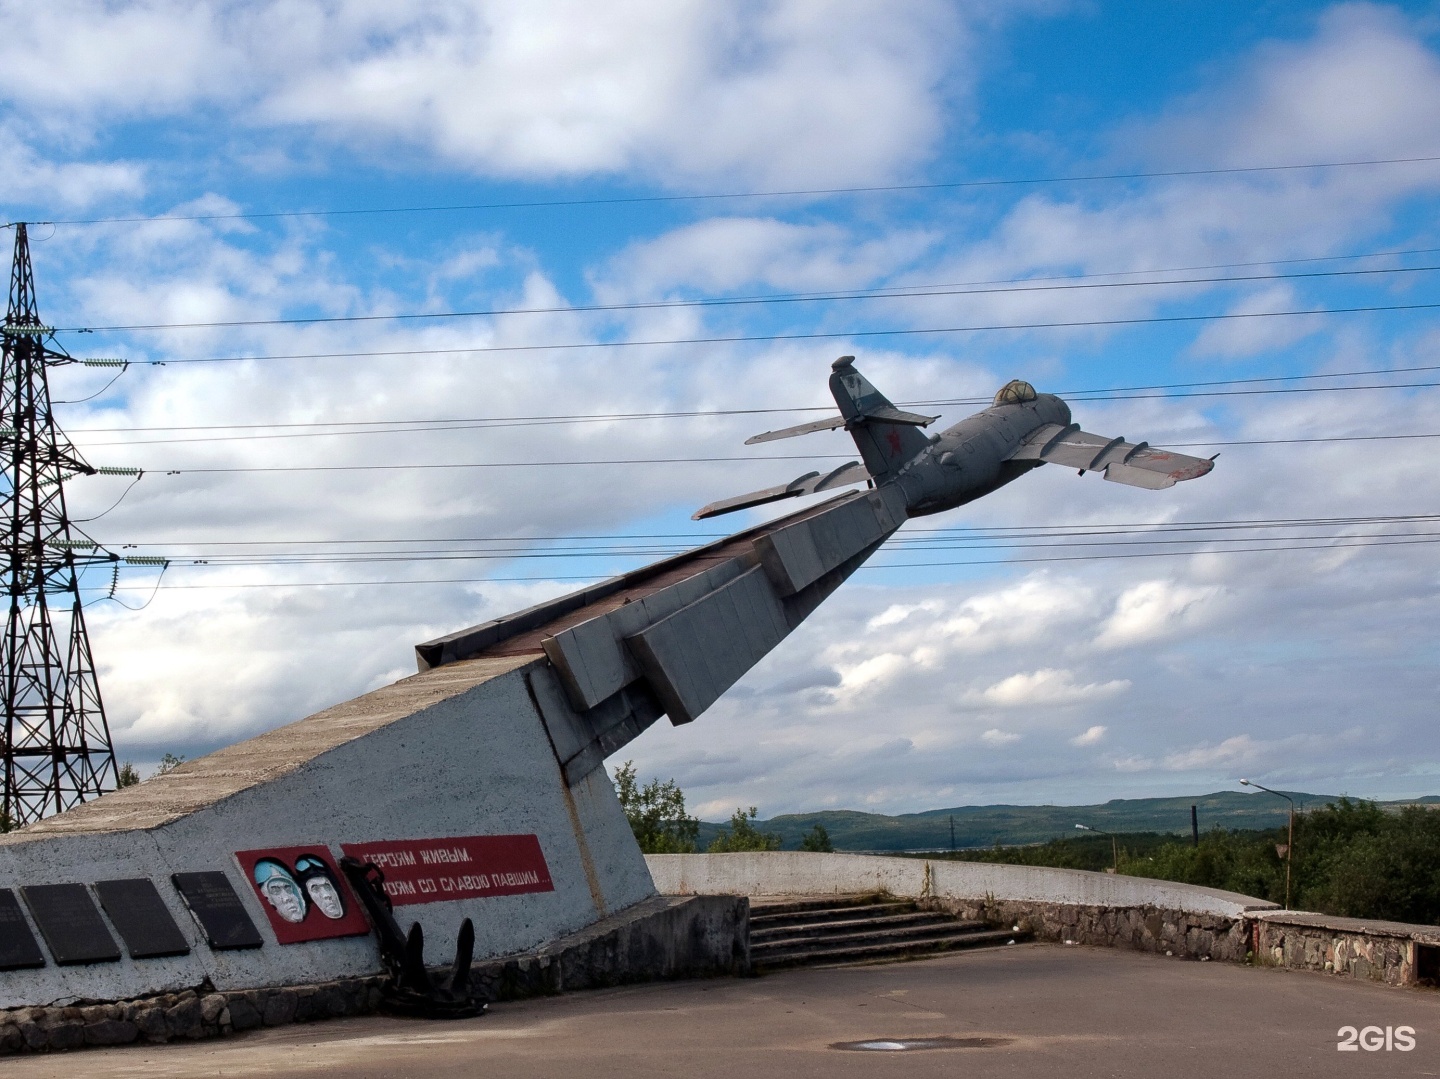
[56,259,1440,333]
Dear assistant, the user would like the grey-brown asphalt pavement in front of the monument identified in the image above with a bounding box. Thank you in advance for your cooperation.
[0,944,1440,1079]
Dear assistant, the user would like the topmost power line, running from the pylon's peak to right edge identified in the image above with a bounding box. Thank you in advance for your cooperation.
[25,156,1440,225]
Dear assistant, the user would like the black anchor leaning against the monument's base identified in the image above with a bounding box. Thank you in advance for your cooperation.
[340,857,485,1018]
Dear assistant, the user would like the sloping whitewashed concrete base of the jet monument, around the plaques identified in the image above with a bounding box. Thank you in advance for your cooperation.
[0,660,654,1007]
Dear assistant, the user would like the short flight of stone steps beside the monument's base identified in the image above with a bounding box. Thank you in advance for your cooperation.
[750,896,1030,974]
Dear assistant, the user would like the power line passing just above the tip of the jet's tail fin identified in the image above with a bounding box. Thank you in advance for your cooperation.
[64,303,1440,366]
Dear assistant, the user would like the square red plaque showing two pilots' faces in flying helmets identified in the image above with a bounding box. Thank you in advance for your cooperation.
[235,843,370,944]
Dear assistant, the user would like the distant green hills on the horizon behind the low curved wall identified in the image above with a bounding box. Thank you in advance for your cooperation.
[698,791,1440,850]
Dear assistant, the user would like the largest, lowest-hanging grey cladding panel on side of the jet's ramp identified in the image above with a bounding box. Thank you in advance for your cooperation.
[626,566,791,723]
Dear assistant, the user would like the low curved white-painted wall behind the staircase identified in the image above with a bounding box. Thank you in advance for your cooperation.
[645,850,1274,918]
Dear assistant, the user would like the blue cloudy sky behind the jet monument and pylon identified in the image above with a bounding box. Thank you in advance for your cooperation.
[0,0,1440,818]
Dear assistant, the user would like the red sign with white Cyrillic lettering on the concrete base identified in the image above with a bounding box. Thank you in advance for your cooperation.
[341,836,554,906]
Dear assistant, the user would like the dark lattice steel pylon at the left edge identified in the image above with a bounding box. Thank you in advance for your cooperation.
[0,223,117,827]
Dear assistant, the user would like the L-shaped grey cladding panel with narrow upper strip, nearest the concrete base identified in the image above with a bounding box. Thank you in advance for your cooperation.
[543,559,744,712]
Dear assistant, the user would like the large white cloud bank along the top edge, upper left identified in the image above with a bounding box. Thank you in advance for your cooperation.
[0,0,992,186]
